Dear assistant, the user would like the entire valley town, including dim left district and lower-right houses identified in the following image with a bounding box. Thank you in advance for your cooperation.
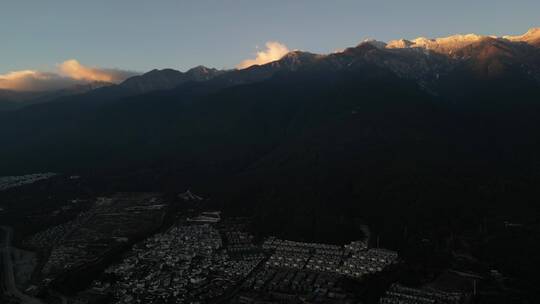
[1,183,486,304]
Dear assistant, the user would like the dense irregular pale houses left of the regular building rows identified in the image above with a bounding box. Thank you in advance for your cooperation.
[95,221,264,303]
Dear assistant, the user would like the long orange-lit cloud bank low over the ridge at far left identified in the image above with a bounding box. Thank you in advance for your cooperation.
[0,59,137,91]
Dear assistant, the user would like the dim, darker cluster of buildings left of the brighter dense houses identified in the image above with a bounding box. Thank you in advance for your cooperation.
[38,193,166,277]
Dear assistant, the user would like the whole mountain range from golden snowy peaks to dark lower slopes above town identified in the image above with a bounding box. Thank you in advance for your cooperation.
[0,29,540,247]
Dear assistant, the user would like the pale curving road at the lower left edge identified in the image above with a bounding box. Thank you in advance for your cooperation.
[0,227,44,304]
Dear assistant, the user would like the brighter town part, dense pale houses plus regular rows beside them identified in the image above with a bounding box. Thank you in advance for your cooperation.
[79,212,398,303]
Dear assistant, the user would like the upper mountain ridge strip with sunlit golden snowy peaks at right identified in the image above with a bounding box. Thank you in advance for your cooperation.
[0,28,540,110]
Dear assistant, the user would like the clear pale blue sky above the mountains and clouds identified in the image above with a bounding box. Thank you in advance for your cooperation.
[0,0,540,73]
